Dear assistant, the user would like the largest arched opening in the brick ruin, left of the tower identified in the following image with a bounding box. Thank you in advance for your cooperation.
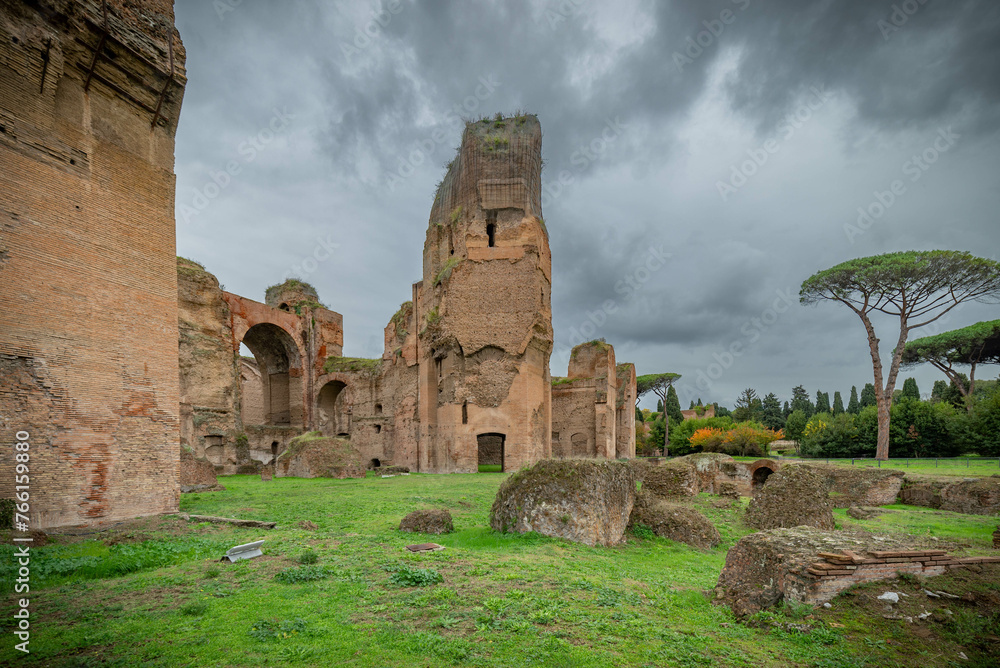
[241,323,301,425]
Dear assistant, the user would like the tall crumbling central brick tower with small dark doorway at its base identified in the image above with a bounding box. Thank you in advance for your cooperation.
[414,115,552,472]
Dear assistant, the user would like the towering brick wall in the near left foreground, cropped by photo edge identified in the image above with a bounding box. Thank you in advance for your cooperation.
[0,0,186,527]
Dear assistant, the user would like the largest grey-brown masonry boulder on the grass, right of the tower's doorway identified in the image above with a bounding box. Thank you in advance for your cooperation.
[490,459,637,546]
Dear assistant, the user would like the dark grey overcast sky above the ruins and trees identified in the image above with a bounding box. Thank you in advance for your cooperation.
[176,0,1000,408]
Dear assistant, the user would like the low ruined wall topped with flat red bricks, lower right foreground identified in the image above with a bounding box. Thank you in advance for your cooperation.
[716,527,1000,616]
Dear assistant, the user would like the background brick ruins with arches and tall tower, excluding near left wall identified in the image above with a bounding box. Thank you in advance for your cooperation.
[177,115,636,473]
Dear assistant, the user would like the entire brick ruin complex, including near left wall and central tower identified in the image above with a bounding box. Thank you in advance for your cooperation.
[0,0,635,527]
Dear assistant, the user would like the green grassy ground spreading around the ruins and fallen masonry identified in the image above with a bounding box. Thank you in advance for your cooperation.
[0,474,1000,667]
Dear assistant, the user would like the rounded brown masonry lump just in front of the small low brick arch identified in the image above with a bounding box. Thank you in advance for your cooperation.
[746,464,834,530]
